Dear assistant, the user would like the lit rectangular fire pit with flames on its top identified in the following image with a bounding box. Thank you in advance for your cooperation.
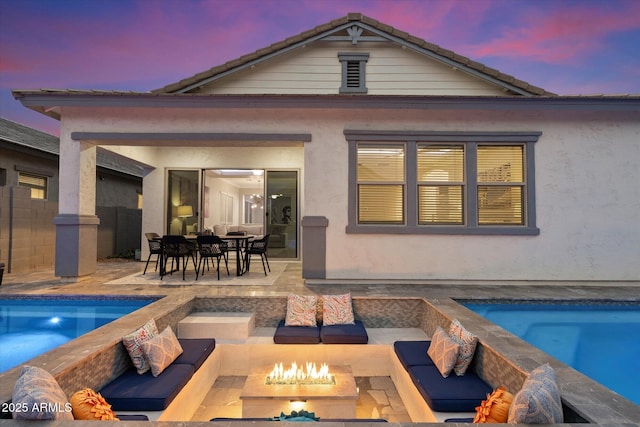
[240,364,358,418]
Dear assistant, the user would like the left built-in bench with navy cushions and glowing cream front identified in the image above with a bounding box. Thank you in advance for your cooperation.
[100,338,219,420]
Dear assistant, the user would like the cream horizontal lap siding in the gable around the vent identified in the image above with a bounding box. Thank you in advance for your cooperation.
[196,42,504,96]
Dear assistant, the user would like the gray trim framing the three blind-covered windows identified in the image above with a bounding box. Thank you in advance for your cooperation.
[344,129,542,236]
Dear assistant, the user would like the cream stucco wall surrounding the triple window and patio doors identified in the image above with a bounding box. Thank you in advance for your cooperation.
[60,108,640,283]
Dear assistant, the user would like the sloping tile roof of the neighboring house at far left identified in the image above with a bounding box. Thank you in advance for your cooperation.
[0,117,146,178]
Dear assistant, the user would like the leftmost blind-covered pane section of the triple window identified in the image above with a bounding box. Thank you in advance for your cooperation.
[357,144,406,224]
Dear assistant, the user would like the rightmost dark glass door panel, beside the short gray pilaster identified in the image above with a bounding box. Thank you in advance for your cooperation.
[265,170,298,259]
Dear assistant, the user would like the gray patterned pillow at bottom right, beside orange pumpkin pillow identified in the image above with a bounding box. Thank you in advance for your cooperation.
[507,363,563,424]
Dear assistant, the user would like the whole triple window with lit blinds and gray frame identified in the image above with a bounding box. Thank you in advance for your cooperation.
[345,130,540,235]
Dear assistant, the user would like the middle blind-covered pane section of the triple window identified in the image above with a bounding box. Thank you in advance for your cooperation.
[417,144,465,224]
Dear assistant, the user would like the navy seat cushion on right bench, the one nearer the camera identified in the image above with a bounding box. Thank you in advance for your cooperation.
[408,366,492,412]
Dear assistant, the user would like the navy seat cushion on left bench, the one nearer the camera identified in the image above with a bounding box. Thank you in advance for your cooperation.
[100,363,195,411]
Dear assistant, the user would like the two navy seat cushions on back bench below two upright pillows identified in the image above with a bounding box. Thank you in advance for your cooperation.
[273,320,369,344]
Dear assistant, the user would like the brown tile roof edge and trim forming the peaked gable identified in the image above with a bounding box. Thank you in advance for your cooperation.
[152,13,556,96]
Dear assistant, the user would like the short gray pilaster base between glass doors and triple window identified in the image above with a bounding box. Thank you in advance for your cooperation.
[301,216,329,279]
